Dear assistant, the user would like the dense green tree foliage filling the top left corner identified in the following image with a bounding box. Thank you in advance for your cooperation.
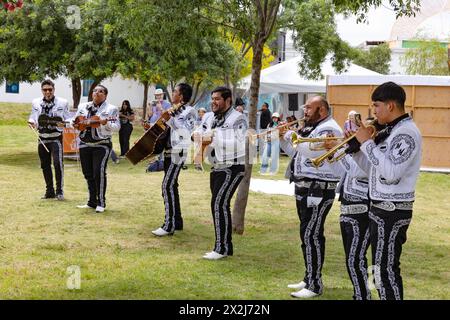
[0,0,75,82]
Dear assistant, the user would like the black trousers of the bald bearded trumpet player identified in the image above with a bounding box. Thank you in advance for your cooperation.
[295,183,335,294]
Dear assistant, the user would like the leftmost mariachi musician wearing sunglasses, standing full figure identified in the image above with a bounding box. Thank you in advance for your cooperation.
[28,80,70,200]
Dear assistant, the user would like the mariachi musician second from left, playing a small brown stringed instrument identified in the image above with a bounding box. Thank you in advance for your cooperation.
[73,85,120,213]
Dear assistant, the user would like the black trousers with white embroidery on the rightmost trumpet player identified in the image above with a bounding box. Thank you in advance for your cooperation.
[369,205,412,300]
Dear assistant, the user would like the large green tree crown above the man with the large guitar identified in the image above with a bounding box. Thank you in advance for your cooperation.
[103,0,241,102]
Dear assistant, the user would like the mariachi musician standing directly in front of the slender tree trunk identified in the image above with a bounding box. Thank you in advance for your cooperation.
[193,87,248,260]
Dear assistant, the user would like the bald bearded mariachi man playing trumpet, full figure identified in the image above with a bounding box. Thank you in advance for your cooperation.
[280,96,343,298]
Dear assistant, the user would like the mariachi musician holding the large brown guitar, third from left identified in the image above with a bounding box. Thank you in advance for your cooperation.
[150,83,196,237]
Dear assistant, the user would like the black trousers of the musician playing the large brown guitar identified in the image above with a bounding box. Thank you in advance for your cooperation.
[161,153,184,233]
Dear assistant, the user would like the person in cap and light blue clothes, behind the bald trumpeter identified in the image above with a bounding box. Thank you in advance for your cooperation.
[261,112,281,174]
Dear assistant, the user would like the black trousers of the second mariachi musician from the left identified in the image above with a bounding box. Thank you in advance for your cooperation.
[80,144,112,208]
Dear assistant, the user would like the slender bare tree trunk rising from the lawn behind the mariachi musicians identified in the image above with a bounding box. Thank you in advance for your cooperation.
[232,38,264,234]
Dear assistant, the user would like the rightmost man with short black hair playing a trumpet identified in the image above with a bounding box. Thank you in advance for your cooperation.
[352,82,422,300]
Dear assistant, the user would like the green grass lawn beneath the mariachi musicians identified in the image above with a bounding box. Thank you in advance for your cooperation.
[0,104,450,300]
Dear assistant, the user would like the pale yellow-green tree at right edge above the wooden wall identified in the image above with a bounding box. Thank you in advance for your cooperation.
[400,39,450,76]
